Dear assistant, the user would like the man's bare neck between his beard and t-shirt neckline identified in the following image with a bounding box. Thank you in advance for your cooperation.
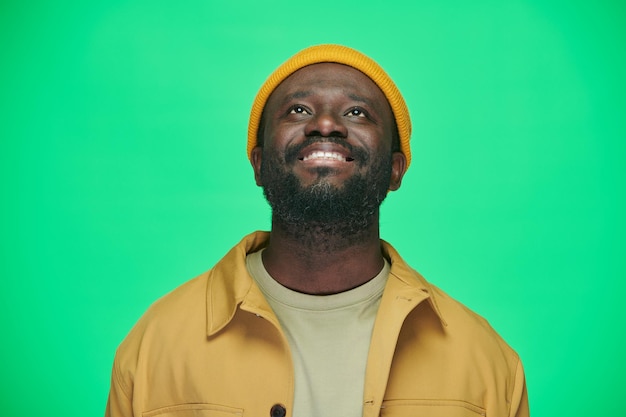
[263,213,383,295]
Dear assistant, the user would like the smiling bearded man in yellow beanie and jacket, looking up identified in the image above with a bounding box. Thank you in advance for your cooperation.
[106,45,528,417]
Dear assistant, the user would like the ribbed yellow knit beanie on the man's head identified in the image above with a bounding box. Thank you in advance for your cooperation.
[247,45,411,168]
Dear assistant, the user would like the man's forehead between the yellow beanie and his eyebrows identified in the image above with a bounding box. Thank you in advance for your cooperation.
[268,62,389,108]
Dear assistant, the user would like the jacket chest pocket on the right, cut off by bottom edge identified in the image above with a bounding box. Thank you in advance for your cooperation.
[380,400,487,417]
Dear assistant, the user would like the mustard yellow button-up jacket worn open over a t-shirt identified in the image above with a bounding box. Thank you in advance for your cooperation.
[106,232,528,417]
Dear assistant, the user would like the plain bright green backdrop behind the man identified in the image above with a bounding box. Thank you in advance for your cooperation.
[0,0,626,417]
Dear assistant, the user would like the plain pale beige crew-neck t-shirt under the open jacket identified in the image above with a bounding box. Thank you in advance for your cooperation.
[246,251,389,417]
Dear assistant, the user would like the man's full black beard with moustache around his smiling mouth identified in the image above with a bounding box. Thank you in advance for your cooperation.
[261,140,391,251]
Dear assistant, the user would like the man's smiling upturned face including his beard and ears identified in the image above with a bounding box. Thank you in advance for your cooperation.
[251,63,405,234]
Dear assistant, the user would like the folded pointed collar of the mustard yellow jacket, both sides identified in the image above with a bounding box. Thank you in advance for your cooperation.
[206,231,446,336]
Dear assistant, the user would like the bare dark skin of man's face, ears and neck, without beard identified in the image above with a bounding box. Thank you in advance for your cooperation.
[251,63,406,295]
